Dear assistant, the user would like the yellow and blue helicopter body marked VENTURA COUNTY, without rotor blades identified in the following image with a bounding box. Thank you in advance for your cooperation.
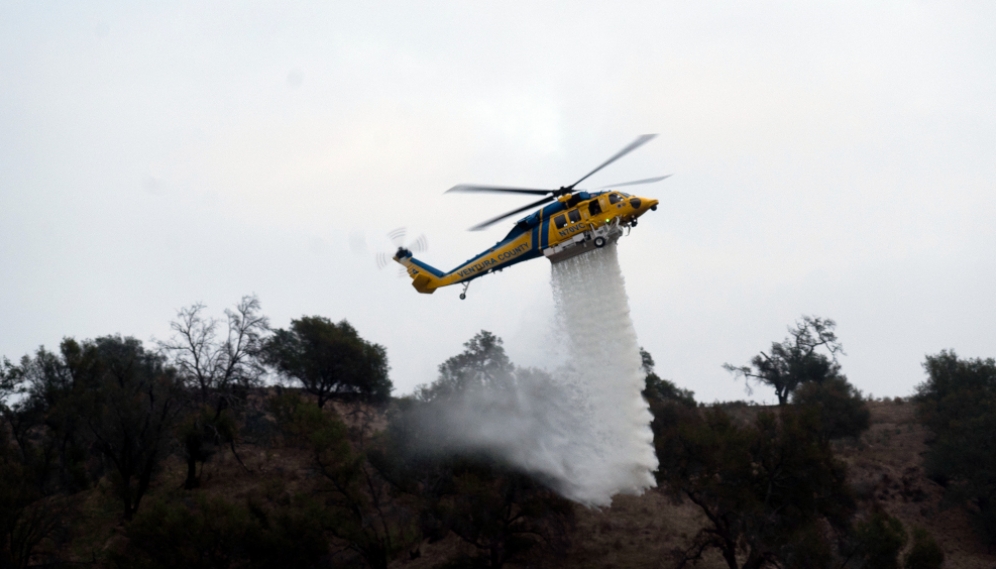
[394,191,658,294]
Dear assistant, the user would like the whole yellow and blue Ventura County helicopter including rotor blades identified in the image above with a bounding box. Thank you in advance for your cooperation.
[393,134,670,300]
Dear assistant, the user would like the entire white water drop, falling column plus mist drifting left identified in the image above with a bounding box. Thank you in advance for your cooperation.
[422,244,657,506]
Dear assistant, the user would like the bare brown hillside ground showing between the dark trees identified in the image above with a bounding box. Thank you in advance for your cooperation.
[11,391,996,569]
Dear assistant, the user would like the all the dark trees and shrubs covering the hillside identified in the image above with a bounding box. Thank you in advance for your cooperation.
[0,310,980,569]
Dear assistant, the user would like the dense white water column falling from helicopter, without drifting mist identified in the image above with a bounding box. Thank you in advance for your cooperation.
[553,244,657,503]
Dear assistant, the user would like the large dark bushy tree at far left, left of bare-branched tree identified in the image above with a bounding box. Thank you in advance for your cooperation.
[5,336,182,519]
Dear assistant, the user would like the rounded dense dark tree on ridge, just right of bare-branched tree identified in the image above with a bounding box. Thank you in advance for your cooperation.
[264,316,392,408]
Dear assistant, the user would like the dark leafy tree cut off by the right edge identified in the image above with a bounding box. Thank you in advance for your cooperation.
[915,350,996,545]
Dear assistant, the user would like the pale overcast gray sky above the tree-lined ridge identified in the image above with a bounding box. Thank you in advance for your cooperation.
[0,1,996,401]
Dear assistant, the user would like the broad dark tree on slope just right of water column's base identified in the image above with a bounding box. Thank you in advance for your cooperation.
[654,408,854,569]
